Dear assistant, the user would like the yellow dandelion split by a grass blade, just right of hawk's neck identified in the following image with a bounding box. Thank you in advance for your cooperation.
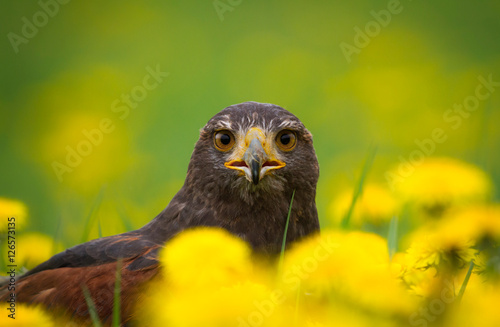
[329,183,399,227]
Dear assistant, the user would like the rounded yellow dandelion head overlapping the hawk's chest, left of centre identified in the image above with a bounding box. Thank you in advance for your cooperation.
[160,227,253,288]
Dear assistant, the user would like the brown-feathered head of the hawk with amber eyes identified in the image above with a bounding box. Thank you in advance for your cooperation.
[190,102,319,200]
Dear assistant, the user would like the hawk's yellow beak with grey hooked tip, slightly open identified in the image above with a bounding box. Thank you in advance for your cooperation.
[224,127,286,185]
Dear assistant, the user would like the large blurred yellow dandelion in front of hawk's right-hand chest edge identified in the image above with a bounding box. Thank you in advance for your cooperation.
[281,231,412,312]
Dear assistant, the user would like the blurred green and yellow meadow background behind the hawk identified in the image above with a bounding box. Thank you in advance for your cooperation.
[0,0,500,245]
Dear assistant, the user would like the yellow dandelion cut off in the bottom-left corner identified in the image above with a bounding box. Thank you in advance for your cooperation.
[0,303,56,327]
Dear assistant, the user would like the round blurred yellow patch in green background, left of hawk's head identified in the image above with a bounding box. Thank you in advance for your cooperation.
[38,110,136,194]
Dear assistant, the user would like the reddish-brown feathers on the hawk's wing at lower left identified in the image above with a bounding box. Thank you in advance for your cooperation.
[0,260,158,323]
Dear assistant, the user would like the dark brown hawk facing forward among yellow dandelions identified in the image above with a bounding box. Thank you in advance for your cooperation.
[0,102,319,323]
